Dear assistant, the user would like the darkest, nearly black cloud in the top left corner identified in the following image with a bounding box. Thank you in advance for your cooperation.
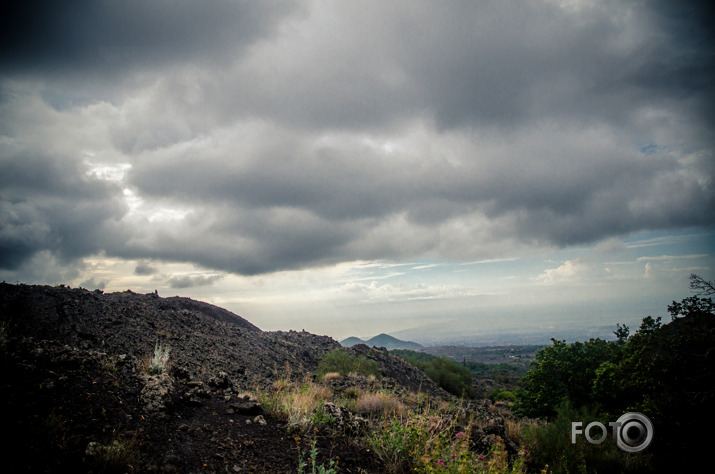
[0,0,299,75]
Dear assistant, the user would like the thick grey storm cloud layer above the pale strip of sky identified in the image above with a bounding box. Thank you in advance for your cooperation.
[0,1,715,276]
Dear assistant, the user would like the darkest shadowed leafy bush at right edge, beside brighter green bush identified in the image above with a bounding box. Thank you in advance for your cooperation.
[593,298,715,472]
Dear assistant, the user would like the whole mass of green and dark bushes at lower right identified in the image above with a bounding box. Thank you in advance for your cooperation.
[515,275,715,472]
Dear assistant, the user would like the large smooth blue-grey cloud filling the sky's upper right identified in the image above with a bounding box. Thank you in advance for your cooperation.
[213,1,714,134]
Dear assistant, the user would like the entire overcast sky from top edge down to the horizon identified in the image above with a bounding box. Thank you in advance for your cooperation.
[0,0,715,338]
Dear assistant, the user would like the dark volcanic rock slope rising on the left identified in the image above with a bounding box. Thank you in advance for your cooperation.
[0,283,445,472]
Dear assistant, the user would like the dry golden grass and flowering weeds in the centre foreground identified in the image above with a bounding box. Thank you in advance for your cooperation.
[255,362,527,473]
